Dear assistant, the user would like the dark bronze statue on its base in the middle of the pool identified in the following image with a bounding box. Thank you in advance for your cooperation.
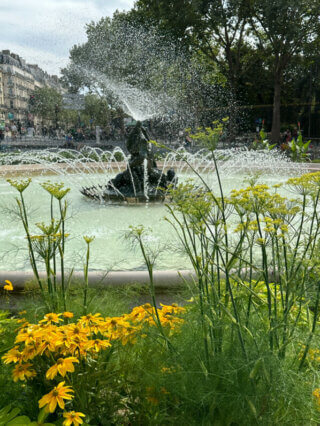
[81,121,177,202]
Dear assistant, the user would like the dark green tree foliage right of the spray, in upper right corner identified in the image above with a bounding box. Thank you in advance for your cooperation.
[135,0,320,138]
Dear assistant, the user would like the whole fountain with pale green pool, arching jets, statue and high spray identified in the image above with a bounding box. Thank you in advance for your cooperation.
[0,20,312,271]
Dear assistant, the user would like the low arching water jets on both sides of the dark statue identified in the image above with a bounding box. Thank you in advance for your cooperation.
[0,147,307,195]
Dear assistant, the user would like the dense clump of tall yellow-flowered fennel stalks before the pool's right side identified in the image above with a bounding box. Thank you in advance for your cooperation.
[164,168,320,372]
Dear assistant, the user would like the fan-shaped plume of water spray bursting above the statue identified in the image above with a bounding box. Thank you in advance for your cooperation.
[63,12,228,128]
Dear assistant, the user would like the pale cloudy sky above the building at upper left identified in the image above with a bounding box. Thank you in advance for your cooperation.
[0,0,134,75]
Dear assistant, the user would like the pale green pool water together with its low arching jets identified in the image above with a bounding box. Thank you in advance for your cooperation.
[0,146,310,271]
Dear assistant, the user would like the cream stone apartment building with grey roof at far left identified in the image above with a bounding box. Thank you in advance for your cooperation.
[0,50,65,127]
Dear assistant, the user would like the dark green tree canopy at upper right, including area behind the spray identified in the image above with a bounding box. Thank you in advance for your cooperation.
[63,0,320,141]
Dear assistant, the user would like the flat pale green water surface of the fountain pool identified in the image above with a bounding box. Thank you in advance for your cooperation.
[0,174,300,270]
